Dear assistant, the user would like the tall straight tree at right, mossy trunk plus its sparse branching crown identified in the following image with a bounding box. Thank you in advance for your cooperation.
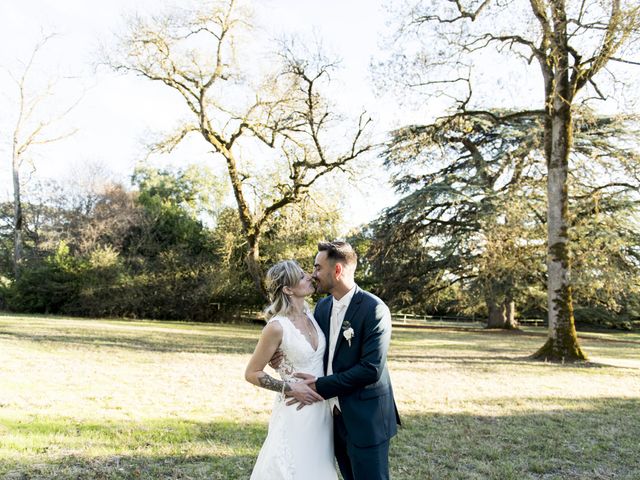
[388,0,640,361]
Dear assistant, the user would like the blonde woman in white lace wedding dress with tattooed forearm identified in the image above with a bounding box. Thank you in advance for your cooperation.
[245,260,337,480]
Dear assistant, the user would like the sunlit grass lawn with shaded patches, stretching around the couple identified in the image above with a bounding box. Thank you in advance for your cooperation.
[0,315,640,480]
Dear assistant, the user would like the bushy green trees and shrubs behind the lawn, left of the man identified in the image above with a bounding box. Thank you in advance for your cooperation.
[1,163,339,320]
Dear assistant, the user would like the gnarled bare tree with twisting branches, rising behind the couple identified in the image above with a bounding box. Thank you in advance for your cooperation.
[107,0,371,292]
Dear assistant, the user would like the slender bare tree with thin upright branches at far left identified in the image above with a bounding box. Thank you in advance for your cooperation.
[9,34,78,278]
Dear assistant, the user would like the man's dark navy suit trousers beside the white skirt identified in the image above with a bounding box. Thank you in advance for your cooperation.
[333,408,389,480]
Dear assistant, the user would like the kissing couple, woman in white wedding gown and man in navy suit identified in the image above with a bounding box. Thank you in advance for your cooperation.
[245,242,400,480]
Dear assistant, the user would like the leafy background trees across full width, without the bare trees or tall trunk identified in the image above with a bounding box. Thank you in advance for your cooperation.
[0,122,640,328]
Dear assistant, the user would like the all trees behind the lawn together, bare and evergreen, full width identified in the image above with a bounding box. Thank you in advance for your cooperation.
[2,0,640,359]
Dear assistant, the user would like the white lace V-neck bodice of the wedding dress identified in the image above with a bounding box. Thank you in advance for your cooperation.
[269,312,326,382]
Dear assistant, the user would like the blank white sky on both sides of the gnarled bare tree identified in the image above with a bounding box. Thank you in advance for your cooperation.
[0,0,399,232]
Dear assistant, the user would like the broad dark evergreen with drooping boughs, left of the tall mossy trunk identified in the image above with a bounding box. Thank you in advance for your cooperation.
[372,111,542,328]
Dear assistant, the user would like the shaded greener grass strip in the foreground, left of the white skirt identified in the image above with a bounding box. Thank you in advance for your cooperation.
[0,417,267,480]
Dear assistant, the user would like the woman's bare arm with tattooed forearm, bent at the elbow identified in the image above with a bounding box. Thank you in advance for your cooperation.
[244,322,324,405]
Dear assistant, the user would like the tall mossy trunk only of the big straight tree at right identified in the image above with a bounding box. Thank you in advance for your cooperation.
[533,8,586,362]
